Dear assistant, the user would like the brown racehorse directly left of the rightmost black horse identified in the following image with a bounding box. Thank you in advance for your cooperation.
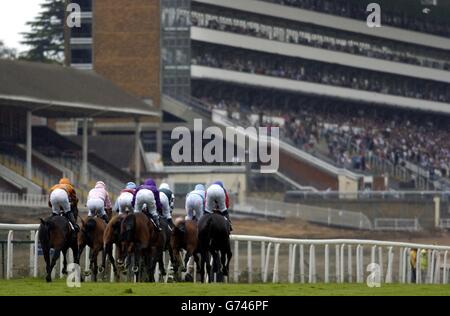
[170,217,200,279]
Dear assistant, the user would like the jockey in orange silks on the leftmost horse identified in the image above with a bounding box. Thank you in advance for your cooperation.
[48,178,79,230]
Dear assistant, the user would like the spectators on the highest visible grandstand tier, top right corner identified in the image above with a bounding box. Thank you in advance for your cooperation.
[264,0,450,37]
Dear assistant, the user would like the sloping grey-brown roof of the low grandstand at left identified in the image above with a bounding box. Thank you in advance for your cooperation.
[0,60,160,118]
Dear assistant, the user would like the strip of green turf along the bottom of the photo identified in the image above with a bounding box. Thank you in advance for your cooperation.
[0,279,450,296]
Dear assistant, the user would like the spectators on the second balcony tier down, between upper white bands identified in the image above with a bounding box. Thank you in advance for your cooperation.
[192,11,450,71]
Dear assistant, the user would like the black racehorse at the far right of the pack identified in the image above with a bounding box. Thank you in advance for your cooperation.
[198,213,233,282]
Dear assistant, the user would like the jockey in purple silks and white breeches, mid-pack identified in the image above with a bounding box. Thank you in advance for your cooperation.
[131,178,162,231]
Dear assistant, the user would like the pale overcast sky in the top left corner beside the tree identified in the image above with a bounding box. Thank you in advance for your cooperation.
[0,0,44,51]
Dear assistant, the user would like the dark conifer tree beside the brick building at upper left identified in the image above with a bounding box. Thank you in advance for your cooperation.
[21,0,65,63]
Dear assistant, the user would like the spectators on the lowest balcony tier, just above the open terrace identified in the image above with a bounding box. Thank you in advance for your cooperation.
[192,45,450,103]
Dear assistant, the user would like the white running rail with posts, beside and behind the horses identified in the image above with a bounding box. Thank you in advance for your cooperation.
[0,224,450,284]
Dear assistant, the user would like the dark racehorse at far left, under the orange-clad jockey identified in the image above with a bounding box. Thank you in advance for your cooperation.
[39,207,80,282]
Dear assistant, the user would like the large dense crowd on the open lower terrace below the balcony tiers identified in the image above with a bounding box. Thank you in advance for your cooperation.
[195,87,450,178]
